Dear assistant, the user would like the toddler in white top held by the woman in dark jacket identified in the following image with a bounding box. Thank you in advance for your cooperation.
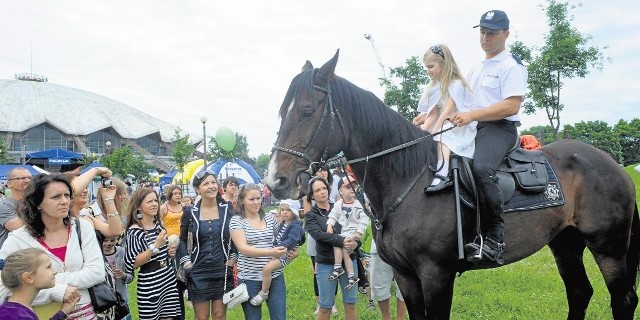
[327,176,369,290]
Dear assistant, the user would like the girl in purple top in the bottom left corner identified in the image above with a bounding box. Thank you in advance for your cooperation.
[0,248,80,320]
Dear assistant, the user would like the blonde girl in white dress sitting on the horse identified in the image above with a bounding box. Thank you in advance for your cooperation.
[414,44,477,192]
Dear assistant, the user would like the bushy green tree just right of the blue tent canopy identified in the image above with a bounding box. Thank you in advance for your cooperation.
[100,145,153,180]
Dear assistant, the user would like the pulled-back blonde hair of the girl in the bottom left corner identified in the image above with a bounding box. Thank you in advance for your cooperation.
[0,248,48,290]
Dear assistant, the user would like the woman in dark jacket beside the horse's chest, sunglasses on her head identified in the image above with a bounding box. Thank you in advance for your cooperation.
[304,177,358,320]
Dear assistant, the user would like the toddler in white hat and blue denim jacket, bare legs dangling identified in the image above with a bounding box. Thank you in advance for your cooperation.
[250,200,304,306]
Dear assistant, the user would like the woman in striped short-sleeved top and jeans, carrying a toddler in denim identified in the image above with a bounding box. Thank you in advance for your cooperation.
[227,183,297,320]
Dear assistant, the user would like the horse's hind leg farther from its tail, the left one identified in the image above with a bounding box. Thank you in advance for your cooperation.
[549,227,593,319]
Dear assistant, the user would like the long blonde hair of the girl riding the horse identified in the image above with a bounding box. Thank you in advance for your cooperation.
[422,44,471,107]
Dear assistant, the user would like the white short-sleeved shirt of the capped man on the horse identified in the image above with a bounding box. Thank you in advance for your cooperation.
[467,50,527,121]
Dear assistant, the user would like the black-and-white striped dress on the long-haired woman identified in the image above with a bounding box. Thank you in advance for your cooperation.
[125,225,180,320]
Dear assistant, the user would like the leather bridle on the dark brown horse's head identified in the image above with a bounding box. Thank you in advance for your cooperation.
[271,84,347,176]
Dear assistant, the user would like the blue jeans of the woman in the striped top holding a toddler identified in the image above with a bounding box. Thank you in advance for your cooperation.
[242,274,284,320]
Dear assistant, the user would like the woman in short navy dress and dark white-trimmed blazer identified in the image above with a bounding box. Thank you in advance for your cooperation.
[178,170,238,320]
